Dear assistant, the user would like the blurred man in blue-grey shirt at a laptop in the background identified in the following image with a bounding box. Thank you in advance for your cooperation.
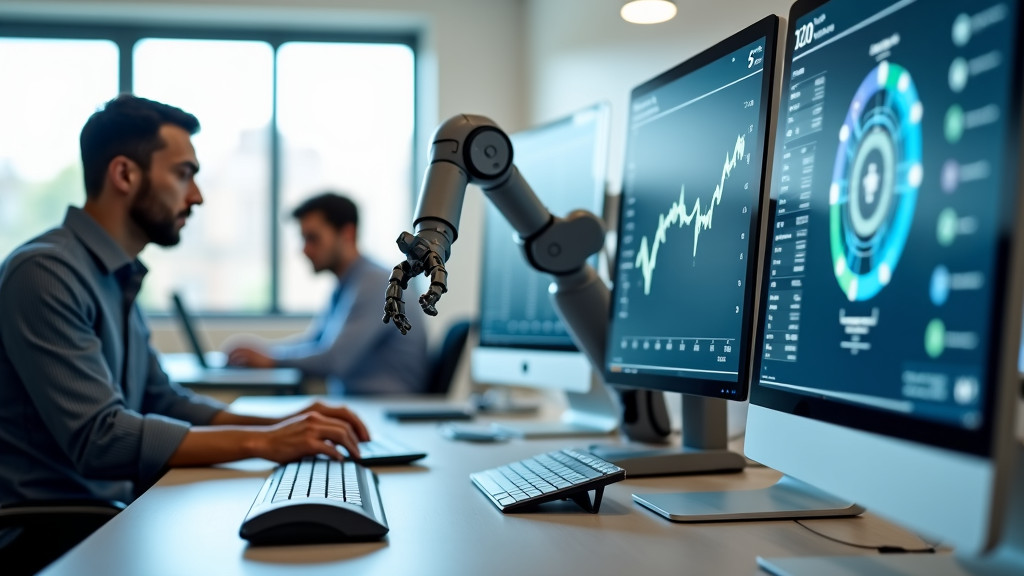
[227,192,427,395]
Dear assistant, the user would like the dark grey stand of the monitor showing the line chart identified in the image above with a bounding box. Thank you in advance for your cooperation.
[589,390,746,478]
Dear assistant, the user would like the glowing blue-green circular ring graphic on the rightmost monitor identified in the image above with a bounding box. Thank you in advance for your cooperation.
[828,61,924,301]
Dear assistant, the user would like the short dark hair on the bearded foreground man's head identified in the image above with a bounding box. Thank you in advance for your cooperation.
[79,94,199,198]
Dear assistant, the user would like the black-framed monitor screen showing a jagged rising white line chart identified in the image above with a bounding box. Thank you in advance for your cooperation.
[605,15,778,400]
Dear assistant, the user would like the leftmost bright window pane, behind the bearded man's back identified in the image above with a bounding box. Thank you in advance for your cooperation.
[0,38,119,257]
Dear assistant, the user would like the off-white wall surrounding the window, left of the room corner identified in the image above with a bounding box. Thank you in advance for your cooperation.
[0,0,528,381]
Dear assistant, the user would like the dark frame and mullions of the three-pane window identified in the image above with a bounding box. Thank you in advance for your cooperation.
[0,18,421,319]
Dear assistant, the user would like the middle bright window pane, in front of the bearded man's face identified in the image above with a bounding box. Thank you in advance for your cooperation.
[132,38,273,312]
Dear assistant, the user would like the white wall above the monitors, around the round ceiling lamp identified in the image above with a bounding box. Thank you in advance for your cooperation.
[525,0,793,194]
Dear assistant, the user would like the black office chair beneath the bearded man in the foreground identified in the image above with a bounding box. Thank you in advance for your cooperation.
[0,499,125,575]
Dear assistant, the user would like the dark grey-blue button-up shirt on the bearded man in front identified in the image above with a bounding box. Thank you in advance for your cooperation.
[0,207,224,503]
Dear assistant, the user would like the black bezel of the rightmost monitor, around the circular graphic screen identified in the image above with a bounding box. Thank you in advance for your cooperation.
[751,0,1024,456]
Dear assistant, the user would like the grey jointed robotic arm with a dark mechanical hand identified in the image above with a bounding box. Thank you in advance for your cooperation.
[384,115,670,442]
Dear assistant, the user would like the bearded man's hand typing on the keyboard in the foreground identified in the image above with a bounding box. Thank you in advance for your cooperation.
[254,412,366,463]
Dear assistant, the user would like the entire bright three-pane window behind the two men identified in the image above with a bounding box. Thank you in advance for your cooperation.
[0,25,415,314]
